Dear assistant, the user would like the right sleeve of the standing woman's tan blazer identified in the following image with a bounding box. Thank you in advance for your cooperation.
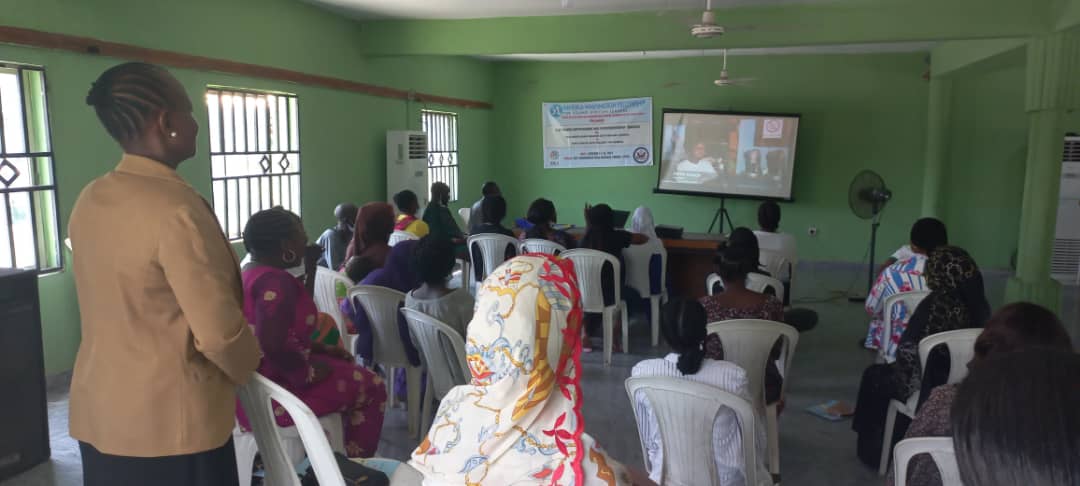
[158,200,262,384]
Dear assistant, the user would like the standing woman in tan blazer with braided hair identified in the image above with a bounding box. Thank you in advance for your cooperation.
[68,63,261,486]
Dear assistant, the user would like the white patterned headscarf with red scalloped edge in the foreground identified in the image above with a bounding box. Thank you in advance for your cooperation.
[409,255,631,486]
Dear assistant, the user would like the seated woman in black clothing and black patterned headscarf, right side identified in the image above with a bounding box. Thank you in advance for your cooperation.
[851,246,990,468]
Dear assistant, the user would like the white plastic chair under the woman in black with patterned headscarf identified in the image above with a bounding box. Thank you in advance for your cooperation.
[878,328,983,476]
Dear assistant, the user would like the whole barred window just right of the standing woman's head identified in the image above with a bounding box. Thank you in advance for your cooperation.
[206,86,300,240]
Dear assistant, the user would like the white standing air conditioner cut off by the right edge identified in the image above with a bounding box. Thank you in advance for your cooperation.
[1050,134,1080,283]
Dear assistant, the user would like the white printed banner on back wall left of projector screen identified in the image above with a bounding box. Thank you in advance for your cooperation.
[543,98,652,168]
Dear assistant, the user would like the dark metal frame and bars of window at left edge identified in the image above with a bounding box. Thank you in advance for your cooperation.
[0,62,65,276]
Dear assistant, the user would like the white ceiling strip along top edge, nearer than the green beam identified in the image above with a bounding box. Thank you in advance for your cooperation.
[306,0,833,18]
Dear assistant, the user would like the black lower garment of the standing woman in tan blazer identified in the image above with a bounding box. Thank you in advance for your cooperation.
[79,437,240,486]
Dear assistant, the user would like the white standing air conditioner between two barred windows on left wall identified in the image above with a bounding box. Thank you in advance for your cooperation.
[387,131,430,210]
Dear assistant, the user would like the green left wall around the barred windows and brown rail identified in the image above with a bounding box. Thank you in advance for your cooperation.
[0,0,492,374]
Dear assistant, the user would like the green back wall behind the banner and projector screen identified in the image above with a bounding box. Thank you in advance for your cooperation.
[492,54,928,261]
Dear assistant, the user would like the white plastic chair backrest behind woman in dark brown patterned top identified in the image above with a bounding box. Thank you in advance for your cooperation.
[707,319,799,409]
